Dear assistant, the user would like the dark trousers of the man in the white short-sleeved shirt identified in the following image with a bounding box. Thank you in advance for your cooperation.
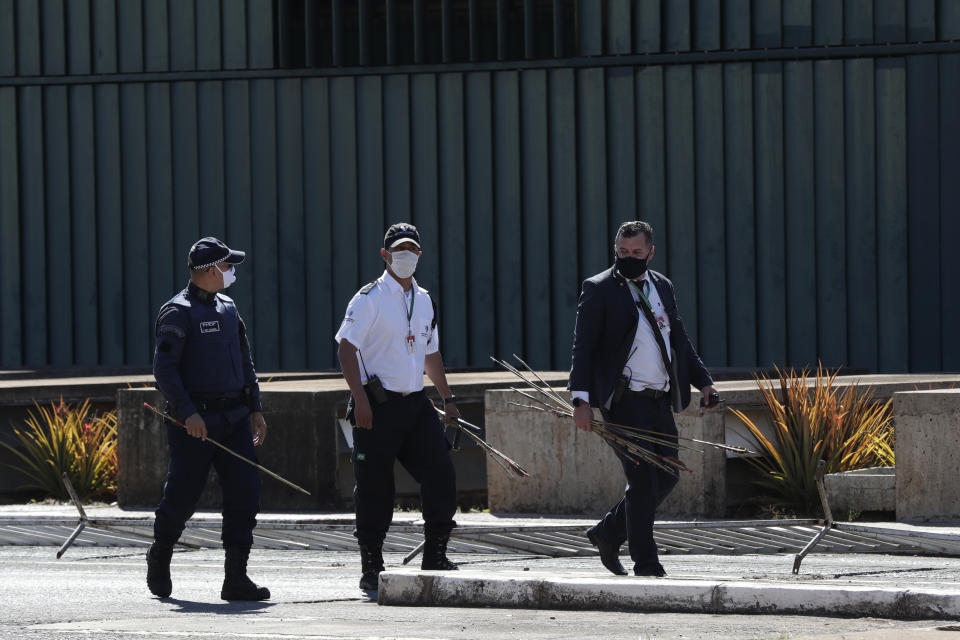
[353,391,457,545]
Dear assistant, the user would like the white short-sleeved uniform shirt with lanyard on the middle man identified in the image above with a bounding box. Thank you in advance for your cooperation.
[334,271,440,393]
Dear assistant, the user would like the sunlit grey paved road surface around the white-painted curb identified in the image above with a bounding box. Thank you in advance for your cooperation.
[0,547,960,640]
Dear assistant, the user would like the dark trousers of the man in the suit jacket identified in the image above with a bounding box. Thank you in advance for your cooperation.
[598,393,678,565]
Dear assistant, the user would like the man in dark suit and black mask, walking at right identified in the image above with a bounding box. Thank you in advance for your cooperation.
[568,221,718,577]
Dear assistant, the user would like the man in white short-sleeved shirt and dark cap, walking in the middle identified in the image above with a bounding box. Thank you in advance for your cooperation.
[335,223,460,590]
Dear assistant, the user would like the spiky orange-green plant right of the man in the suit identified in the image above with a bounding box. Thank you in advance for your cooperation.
[731,365,893,513]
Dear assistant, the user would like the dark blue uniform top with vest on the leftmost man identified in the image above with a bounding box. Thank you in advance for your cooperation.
[153,282,262,419]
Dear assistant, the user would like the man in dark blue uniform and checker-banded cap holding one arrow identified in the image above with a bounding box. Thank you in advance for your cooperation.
[147,237,270,600]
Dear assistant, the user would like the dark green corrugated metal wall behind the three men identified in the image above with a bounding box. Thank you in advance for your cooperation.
[0,0,960,371]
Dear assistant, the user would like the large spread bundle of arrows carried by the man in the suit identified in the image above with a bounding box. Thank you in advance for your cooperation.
[491,354,751,475]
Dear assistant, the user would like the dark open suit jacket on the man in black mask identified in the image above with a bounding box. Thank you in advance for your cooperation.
[567,267,713,411]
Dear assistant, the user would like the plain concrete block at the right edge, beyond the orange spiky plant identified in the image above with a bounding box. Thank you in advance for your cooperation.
[893,389,960,521]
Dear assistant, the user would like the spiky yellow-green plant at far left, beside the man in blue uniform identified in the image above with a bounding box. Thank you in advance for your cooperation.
[0,398,117,501]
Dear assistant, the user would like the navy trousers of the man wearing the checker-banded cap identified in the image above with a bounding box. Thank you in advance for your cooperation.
[153,413,260,548]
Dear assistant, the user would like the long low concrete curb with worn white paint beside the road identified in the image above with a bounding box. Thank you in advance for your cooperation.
[378,569,960,620]
